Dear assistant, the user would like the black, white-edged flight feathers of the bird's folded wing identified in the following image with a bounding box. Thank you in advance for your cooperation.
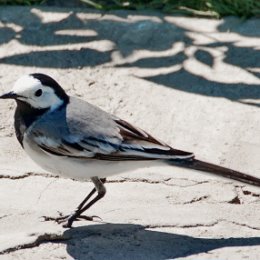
[33,115,194,161]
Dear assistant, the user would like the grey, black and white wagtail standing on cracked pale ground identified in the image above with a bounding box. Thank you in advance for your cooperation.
[0,73,260,227]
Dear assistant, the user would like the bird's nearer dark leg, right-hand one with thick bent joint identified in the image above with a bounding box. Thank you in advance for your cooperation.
[63,177,106,227]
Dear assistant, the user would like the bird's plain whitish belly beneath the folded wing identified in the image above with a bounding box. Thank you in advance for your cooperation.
[23,136,160,180]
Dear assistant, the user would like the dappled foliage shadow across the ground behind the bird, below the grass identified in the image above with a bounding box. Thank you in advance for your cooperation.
[0,7,260,107]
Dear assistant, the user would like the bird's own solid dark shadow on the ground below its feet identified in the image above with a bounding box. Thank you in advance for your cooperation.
[61,224,260,260]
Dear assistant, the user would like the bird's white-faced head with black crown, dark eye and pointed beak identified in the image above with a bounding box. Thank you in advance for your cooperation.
[0,73,69,110]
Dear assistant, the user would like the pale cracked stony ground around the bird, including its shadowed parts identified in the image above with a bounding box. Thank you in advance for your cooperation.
[0,7,260,260]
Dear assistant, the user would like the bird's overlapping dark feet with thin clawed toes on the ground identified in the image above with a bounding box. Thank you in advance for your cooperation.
[43,212,102,228]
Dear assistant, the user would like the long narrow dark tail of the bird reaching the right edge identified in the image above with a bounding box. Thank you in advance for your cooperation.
[171,159,260,187]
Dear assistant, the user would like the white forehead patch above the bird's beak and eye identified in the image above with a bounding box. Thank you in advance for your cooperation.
[12,75,42,93]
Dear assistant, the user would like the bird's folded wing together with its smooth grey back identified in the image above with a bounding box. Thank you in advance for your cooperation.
[30,99,194,161]
